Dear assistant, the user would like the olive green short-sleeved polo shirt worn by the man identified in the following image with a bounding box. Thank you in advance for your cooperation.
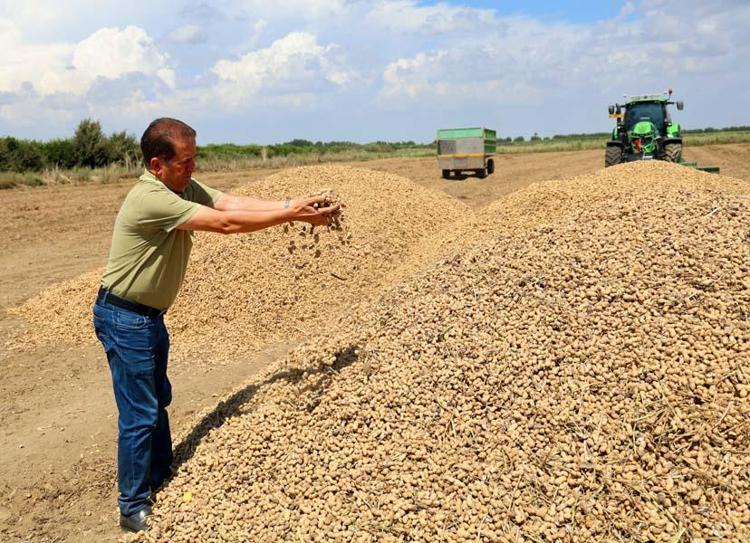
[102,171,222,310]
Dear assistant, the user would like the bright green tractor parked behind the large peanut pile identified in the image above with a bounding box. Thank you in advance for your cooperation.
[604,89,683,167]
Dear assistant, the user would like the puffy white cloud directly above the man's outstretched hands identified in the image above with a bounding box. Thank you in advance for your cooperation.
[212,32,354,105]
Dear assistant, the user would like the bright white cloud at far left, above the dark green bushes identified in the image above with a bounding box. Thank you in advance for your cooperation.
[0,20,176,137]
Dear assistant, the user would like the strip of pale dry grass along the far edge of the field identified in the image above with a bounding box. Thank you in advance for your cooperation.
[0,131,750,189]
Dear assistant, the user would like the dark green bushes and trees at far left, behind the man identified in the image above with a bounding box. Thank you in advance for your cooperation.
[0,119,141,172]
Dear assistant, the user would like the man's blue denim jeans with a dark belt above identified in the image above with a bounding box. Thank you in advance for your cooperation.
[93,299,172,515]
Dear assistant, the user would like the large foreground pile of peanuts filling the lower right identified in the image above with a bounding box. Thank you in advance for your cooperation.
[135,162,750,543]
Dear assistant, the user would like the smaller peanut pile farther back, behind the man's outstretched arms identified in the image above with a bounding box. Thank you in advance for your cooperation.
[11,165,473,369]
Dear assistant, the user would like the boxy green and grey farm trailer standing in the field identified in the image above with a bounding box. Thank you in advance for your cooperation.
[437,128,497,179]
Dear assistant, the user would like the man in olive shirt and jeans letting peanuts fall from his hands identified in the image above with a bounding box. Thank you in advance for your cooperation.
[93,118,338,531]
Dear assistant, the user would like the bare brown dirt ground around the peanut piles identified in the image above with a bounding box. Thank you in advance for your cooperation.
[0,144,750,542]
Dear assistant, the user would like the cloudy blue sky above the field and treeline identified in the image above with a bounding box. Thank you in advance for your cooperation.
[0,0,750,143]
